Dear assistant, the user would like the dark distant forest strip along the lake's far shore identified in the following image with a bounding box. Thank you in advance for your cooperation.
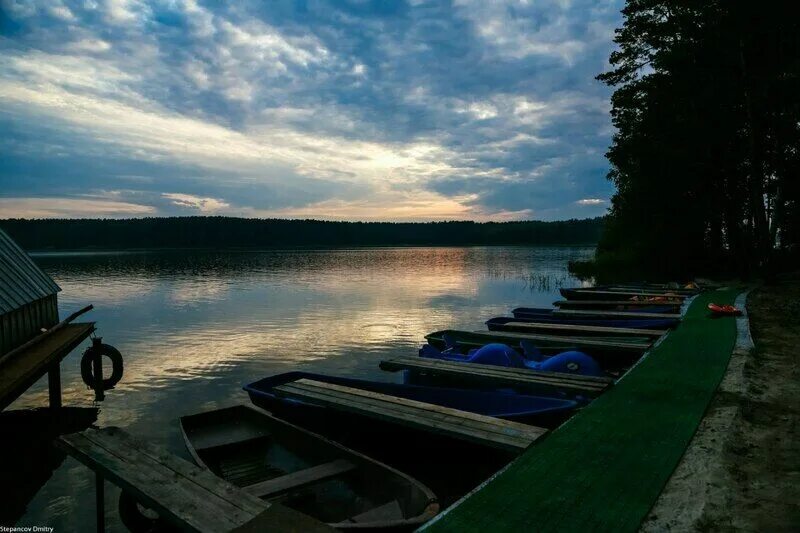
[0,217,603,250]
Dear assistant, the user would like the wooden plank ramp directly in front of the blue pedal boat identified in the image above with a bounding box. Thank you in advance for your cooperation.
[380,357,614,396]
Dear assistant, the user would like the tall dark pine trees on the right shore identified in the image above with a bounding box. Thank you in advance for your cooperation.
[594,0,800,277]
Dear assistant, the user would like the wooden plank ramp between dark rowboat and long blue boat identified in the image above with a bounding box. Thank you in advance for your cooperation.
[273,379,547,453]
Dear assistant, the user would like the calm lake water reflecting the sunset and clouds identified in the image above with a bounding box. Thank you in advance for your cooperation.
[12,248,592,531]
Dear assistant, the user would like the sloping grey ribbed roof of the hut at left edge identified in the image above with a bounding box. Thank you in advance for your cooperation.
[0,229,61,315]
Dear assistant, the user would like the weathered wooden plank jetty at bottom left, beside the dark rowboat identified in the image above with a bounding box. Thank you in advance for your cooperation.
[56,427,332,532]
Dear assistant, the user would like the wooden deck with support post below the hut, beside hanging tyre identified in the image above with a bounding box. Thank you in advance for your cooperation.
[0,322,94,410]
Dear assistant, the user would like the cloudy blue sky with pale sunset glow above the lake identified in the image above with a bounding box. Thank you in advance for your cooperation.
[0,0,622,221]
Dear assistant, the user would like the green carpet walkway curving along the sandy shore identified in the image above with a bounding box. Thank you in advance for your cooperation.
[425,289,740,533]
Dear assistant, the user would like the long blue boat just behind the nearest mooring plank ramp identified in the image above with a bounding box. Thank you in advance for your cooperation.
[244,372,579,426]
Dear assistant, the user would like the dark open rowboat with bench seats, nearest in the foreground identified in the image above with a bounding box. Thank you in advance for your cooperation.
[180,405,439,530]
